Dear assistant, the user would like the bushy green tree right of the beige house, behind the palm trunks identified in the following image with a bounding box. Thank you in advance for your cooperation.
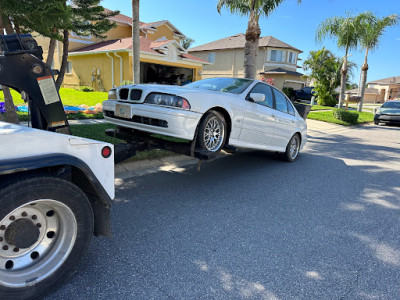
[303,48,355,106]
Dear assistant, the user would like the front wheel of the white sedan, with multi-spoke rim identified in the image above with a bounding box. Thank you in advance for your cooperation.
[197,110,226,153]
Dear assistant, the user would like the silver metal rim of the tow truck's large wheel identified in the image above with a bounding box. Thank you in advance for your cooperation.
[0,199,78,288]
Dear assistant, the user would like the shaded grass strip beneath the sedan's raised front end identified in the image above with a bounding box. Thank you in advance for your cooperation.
[71,123,174,161]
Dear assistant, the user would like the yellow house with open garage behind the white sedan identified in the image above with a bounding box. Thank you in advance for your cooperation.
[37,14,208,91]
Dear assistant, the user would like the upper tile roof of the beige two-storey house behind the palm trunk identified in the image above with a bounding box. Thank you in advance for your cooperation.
[188,33,303,52]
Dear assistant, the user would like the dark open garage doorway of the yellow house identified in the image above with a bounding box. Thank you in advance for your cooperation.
[140,62,194,85]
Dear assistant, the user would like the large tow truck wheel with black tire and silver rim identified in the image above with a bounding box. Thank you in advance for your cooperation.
[0,175,94,299]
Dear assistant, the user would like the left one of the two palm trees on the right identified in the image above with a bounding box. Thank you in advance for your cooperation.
[316,13,360,107]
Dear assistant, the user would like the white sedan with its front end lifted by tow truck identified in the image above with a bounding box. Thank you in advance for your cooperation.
[103,78,307,161]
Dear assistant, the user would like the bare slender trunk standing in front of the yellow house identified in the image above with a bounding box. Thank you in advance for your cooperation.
[132,0,140,84]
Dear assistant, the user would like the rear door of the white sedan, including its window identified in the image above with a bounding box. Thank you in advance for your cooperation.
[271,88,296,147]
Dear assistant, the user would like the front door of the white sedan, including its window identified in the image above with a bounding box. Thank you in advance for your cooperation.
[239,83,275,146]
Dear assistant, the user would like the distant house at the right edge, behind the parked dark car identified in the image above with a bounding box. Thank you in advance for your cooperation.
[346,76,400,103]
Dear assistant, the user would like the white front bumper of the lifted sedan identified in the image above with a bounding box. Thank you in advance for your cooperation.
[103,101,202,140]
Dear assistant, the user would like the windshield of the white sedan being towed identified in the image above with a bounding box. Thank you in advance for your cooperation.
[186,78,253,94]
